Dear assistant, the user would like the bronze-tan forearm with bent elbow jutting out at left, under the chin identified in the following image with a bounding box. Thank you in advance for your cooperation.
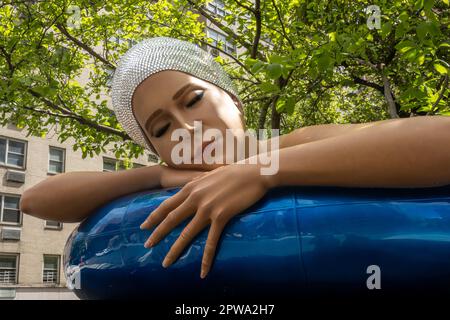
[20,165,162,222]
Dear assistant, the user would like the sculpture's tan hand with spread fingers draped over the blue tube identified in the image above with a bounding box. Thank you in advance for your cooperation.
[141,164,269,278]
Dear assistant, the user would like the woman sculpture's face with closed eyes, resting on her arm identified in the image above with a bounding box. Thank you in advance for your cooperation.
[132,70,245,170]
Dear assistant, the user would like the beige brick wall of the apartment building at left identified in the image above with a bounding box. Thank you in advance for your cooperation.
[0,120,154,287]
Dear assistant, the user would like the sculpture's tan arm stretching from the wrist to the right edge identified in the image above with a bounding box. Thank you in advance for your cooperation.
[267,116,450,187]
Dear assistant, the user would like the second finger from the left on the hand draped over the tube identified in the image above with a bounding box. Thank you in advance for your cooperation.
[144,200,195,248]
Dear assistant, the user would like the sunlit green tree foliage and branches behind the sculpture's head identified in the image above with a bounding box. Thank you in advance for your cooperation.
[0,0,450,158]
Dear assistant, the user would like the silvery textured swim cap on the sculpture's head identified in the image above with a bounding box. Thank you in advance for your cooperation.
[111,37,242,154]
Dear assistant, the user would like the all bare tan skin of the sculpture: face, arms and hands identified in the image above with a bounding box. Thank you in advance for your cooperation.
[21,71,450,278]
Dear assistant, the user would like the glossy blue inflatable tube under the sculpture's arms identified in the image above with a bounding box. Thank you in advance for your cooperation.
[64,185,450,299]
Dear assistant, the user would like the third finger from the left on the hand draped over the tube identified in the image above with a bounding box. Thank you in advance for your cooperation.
[163,215,209,268]
